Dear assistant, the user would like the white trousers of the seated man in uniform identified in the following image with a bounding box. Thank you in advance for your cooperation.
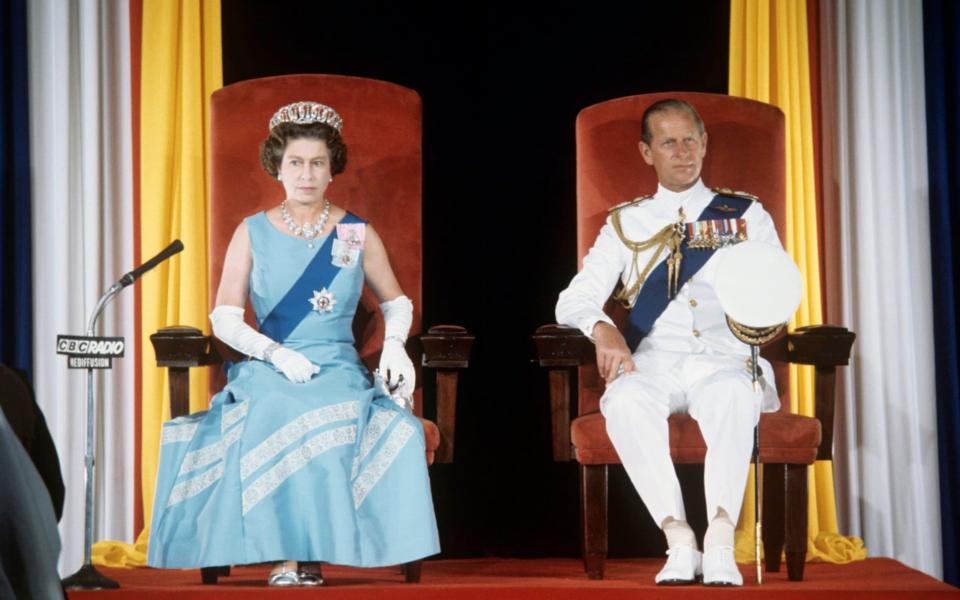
[600,351,762,527]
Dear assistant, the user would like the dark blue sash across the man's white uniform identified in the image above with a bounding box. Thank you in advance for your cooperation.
[623,194,753,352]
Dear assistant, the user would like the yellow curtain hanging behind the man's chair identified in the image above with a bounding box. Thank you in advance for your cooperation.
[729,0,867,563]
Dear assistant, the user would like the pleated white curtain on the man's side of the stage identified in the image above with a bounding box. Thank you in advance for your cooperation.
[821,0,942,577]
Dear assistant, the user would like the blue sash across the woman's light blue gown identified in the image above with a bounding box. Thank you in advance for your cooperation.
[260,212,366,343]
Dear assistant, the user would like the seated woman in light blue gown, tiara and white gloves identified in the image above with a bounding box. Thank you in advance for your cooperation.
[148,102,439,586]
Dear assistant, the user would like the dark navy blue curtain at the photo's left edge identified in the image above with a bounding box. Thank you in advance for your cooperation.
[0,0,33,376]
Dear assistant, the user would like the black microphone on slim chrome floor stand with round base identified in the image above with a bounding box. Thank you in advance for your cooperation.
[63,240,183,590]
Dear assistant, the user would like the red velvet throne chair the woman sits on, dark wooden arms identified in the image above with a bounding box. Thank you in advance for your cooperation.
[151,75,473,583]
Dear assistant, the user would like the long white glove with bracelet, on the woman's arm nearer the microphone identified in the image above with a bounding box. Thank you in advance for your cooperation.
[210,304,320,383]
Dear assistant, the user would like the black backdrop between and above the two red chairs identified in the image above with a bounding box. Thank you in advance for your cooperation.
[222,0,729,557]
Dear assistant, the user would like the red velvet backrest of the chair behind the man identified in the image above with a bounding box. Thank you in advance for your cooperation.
[576,92,789,414]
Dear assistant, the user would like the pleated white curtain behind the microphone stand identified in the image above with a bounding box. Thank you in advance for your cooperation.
[28,0,136,575]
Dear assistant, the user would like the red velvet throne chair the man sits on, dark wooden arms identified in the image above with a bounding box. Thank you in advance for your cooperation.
[533,93,855,580]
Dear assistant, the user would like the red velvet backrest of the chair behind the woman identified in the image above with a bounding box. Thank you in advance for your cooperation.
[209,75,423,410]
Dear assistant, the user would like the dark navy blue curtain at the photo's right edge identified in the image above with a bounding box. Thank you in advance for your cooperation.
[923,0,960,585]
